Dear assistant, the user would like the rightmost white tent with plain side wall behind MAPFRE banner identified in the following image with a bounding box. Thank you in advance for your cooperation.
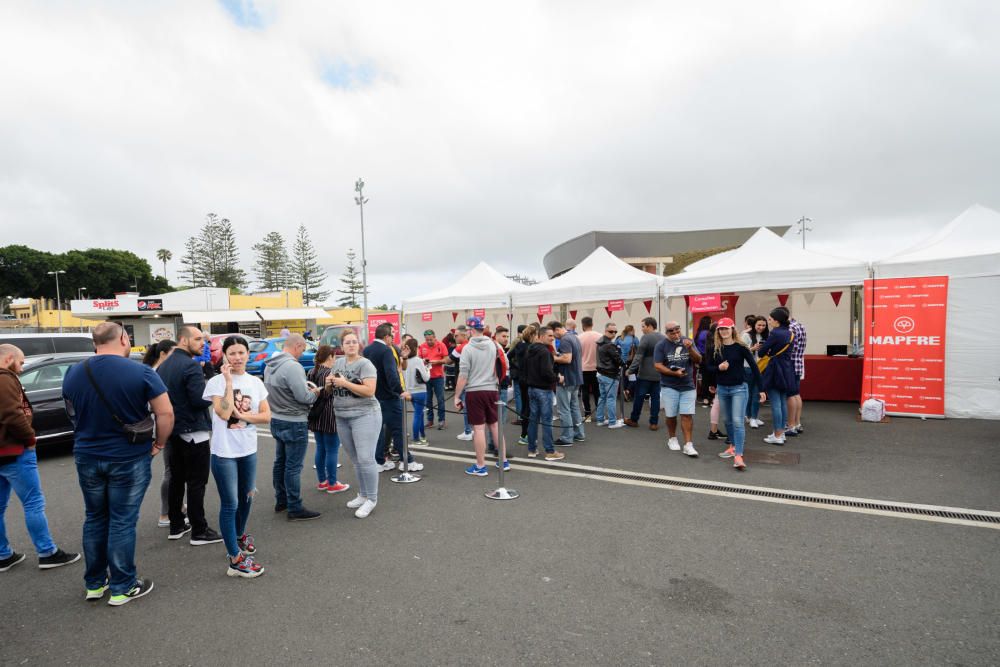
[874,204,1000,419]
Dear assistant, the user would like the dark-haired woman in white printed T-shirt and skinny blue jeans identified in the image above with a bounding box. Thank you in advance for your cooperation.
[204,336,271,578]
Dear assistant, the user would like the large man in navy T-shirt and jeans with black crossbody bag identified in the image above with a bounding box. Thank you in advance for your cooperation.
[63,322,174,606]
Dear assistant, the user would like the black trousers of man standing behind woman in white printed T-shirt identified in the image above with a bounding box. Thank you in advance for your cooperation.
[165,435,212,535]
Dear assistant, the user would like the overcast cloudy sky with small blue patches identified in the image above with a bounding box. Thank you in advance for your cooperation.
[0,0,1000,304]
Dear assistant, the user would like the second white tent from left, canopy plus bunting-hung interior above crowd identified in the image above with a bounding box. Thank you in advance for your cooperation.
[514,246,661,331]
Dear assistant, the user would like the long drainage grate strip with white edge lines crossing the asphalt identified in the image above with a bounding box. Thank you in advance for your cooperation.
[420,447,1000,525]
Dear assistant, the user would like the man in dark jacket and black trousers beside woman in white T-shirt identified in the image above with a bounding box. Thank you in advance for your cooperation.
[156,325,222,546]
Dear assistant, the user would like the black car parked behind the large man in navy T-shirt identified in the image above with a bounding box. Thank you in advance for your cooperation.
[21,353,94,445]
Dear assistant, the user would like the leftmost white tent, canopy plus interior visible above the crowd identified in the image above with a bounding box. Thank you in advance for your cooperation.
[403,262,526,339]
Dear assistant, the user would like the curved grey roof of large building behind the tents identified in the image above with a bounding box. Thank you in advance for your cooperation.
[542,225,790,278]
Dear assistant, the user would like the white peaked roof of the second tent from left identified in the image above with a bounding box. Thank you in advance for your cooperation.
[514,246,660,307]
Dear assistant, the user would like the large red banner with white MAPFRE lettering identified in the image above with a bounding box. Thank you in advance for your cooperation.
[861,276,948,417]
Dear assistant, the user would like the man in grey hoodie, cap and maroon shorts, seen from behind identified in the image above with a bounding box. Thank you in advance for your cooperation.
[455,317,510,477]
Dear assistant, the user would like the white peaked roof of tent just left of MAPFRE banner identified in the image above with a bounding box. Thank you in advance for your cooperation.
[663,227,868,296]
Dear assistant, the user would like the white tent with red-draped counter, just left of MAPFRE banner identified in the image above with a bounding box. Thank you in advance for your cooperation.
[663,227,869,400]
